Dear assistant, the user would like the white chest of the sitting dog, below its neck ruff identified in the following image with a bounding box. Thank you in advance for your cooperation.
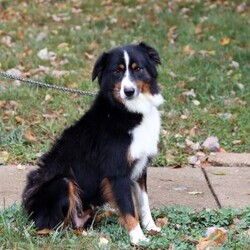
[130,107,160,180]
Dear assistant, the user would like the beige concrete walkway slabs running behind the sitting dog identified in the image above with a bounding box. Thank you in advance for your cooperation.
[0,153,250,210]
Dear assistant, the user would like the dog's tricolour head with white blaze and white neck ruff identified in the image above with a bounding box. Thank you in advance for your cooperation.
[92,43,163,112]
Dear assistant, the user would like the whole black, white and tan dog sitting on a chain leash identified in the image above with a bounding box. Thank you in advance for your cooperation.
[23,43,163,244]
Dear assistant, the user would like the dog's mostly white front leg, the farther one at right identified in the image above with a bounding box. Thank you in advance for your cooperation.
[134,170,161,232]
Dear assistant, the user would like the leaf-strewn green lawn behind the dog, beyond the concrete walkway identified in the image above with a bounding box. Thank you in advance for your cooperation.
[0,0,250,166]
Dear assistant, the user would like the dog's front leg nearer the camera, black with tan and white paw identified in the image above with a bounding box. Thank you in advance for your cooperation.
[102,177,149,245]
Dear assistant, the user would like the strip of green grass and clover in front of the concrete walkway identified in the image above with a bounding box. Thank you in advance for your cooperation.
[0,205,250,250]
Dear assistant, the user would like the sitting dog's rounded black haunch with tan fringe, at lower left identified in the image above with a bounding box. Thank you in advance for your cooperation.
[22,168,82,229]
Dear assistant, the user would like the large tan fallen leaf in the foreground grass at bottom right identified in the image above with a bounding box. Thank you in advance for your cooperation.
[196,227,228,250]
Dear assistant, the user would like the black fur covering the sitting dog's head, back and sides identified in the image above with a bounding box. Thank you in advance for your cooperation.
[23,43,160,232]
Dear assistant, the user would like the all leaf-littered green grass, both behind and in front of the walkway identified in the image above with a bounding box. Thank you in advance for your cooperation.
[0,0,250,249]
